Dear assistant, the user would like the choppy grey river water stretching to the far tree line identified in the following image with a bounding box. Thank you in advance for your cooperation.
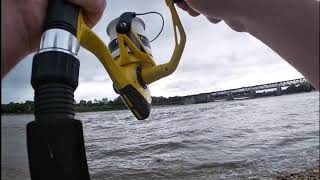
[1,92,319,179]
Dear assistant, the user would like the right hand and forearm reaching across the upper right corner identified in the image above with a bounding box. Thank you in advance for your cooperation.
[178,0,320,89]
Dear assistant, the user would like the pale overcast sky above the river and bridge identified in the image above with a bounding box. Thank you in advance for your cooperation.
[1,0,303,104]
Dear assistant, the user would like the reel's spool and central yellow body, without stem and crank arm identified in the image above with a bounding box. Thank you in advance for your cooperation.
[107,15,155,119]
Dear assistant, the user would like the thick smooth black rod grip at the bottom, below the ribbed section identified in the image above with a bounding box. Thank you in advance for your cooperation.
[27,119,90,180]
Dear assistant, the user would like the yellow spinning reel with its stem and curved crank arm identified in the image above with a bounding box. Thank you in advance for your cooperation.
[77,0,186,120]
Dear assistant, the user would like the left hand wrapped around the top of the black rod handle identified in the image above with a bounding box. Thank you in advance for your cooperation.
[1,0,106,77]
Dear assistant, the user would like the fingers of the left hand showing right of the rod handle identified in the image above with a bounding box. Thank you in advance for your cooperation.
[68,0,107,27]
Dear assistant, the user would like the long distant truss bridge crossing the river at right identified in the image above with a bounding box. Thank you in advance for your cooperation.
[184,78,313,104]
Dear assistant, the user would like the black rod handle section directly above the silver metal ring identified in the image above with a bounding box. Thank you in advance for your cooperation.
[44,0,80,36]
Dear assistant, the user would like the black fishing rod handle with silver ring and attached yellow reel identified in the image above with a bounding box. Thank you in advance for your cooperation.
[27,0,186,180]
